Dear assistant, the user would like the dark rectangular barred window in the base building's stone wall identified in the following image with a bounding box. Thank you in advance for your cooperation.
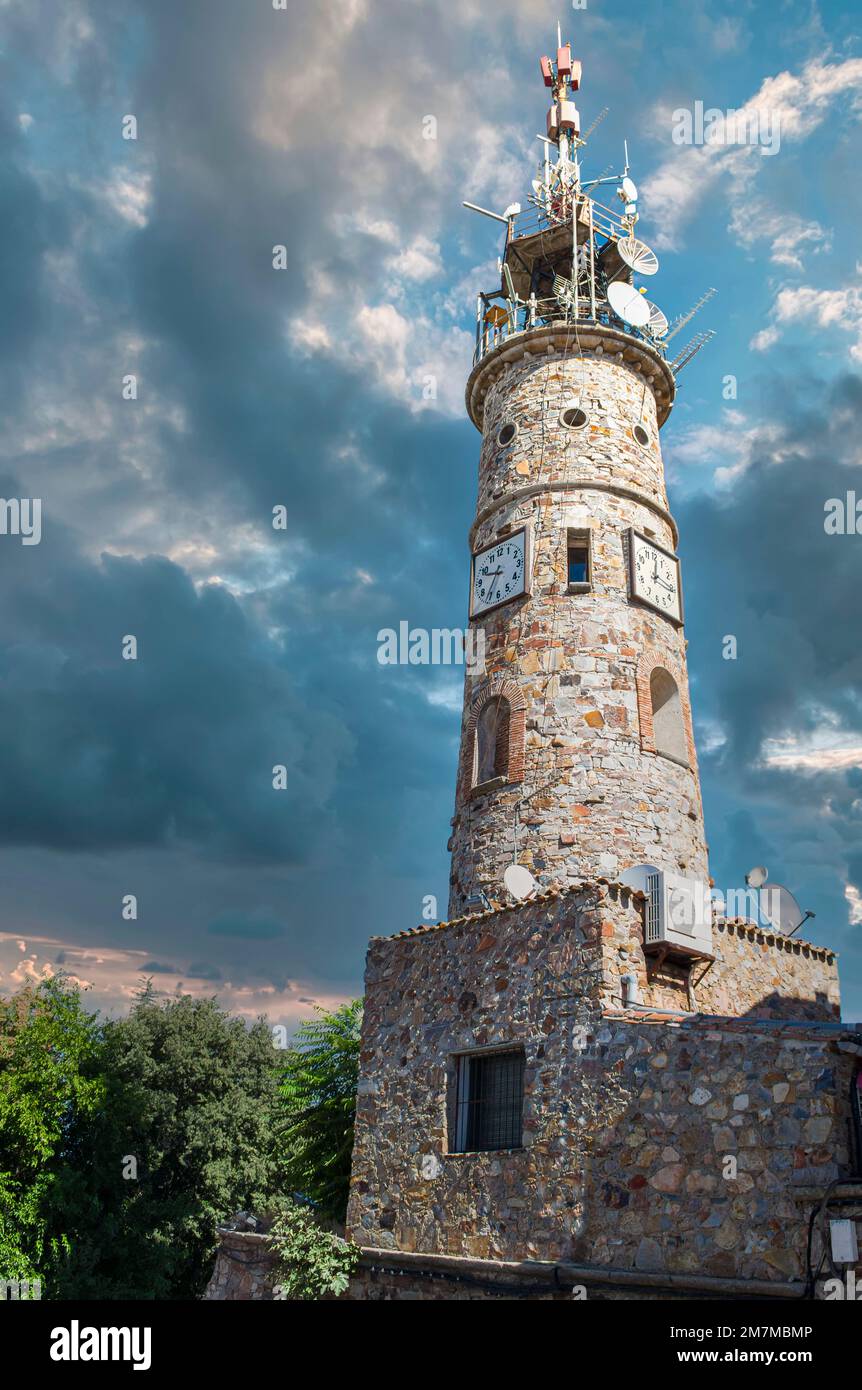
[452,1051,524,1154]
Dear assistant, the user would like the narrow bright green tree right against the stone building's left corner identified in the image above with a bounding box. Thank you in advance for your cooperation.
[281,999,361,1222]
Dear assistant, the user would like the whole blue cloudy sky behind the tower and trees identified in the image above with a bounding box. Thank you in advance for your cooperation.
[0,0,862,1026]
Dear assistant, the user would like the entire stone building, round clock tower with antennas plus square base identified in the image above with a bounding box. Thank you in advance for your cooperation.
[348,38,862,1298]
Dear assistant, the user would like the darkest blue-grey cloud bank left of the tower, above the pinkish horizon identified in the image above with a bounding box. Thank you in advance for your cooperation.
[0,543,352,862]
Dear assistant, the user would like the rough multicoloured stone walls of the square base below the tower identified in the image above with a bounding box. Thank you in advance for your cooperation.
[348,884,856,1280]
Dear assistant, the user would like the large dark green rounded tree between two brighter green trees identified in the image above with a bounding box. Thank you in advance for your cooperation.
[57,988,278,1298]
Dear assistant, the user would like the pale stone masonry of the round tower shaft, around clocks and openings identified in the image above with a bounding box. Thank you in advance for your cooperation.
[449,334,708,916]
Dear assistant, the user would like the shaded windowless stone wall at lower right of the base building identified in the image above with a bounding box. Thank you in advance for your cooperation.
[573,1019,852,1279]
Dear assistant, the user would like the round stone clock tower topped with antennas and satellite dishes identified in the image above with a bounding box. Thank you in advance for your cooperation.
[449,35,708,916]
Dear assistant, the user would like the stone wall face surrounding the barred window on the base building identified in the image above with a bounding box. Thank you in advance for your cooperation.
[348,890,628,1258]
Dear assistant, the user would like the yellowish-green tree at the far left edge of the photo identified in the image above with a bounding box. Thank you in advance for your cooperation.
[0,976,104,1279]
